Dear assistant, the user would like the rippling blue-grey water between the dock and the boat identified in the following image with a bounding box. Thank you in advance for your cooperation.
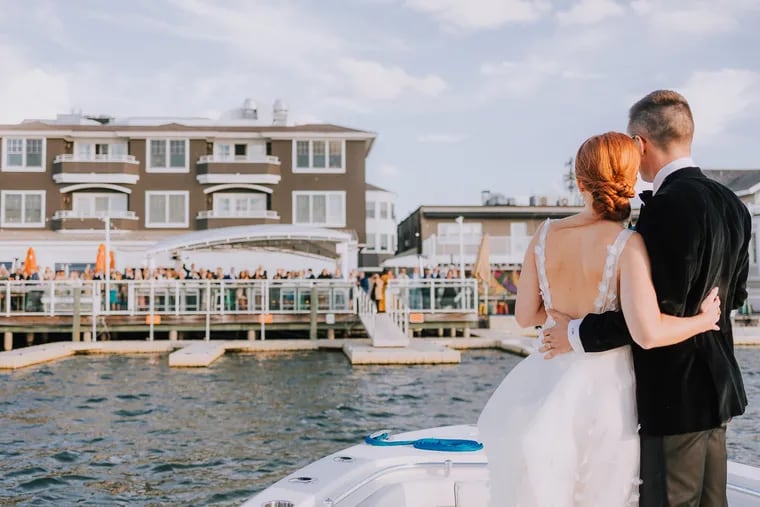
[0,349,760,506]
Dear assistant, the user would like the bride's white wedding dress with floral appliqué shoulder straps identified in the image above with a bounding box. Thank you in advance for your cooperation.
[478,220,640,507]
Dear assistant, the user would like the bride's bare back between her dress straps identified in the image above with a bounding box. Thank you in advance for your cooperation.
[545,215,623,318]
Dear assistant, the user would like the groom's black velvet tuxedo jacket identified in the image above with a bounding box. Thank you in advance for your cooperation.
[580,167,752,435]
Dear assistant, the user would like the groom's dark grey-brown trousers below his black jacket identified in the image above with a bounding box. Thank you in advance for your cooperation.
[639,426,728,507]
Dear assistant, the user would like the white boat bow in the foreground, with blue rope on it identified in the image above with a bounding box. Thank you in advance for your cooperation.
[243,425,760,507]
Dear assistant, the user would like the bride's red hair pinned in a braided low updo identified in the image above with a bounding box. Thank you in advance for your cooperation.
[575,132,641,222]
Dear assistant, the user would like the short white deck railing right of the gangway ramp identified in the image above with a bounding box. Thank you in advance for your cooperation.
[388,278,478,313]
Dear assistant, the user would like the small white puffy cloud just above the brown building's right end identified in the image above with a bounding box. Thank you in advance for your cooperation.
[338,58,447,100]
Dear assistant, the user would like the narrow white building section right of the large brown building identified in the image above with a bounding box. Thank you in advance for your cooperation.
[360,183,397,270]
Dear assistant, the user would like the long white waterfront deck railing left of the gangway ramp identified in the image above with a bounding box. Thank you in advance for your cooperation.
[0,279,357,317]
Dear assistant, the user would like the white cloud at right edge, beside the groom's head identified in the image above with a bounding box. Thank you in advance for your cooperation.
[678,69,760,137]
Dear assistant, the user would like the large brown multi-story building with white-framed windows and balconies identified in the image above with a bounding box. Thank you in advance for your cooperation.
[0,102,375,274]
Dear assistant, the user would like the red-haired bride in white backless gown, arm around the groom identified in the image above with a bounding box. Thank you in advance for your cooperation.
[478,132,720,507]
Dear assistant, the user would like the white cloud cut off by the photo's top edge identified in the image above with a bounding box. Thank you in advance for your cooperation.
[404,0,551,30]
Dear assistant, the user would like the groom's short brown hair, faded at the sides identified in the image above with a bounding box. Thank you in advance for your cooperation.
[628,90,694,148]
